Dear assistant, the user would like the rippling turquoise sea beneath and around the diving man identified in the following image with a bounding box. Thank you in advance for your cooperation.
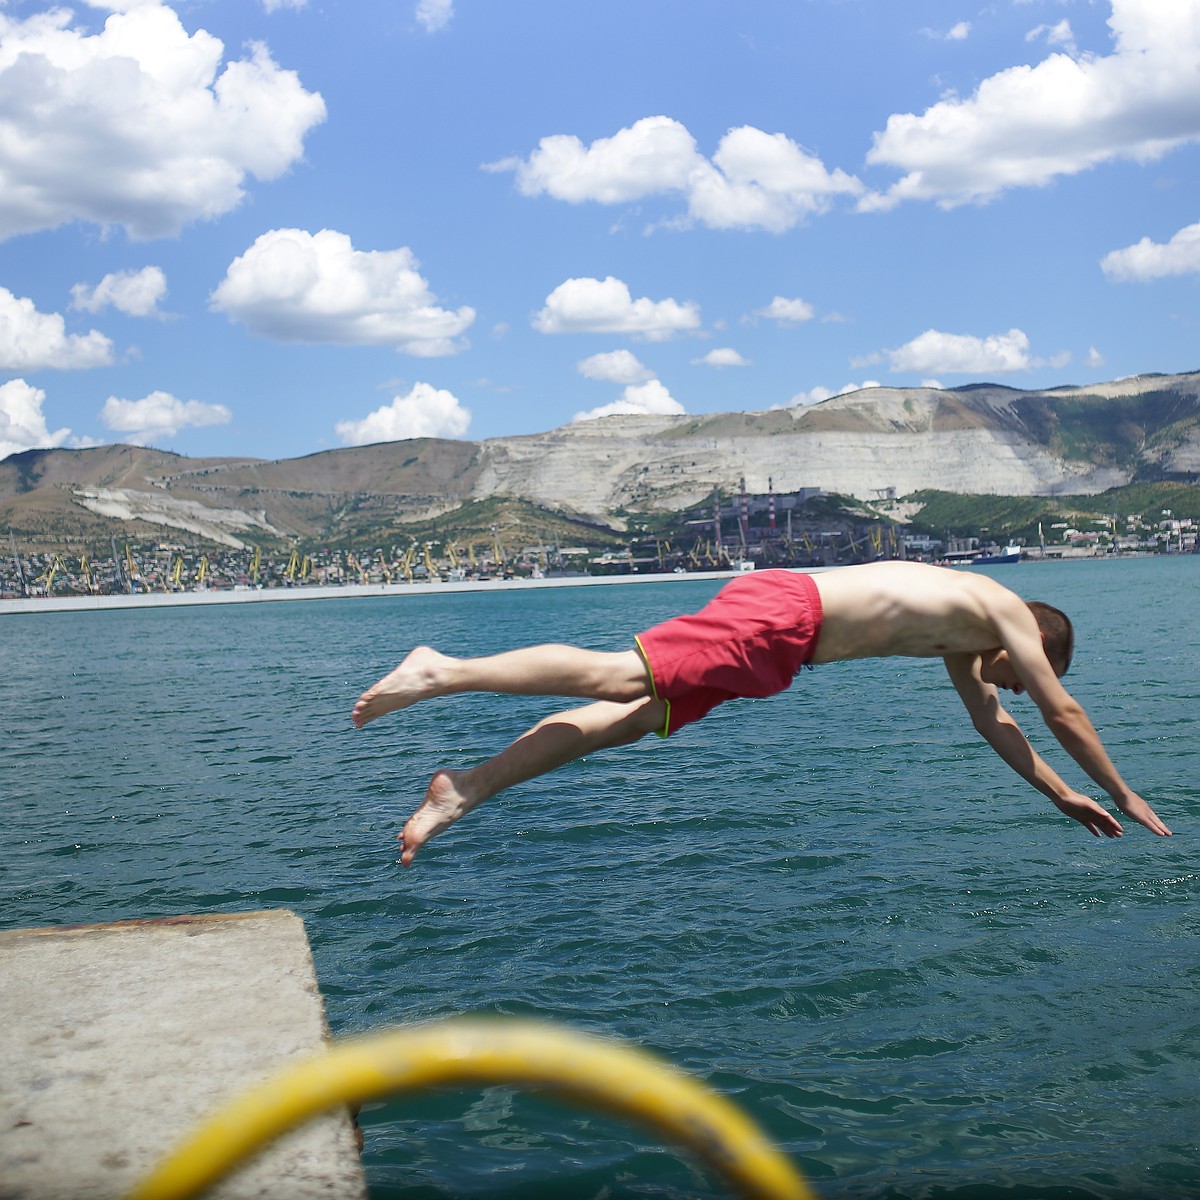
[0,557,1200,1200]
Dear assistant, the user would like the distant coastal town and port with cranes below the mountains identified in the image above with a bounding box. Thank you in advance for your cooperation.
[0,497,1200,600]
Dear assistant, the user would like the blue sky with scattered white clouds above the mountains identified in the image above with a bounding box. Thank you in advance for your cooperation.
[0,0,1200,458]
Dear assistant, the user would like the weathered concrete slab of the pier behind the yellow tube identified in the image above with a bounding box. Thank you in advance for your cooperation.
[0,911,366,1200]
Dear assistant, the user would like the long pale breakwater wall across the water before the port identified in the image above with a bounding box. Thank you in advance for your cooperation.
[0,568,763,617]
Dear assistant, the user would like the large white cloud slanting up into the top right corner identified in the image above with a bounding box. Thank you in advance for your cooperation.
[859,0,1200,210]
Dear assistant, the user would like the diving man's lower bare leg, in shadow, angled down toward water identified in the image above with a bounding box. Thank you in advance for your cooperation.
[400,696,666,866]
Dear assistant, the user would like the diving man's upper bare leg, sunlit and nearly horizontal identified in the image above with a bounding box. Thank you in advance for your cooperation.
[350,646,650,728]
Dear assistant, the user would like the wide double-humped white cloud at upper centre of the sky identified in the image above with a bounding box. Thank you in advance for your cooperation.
[487,116,864,233]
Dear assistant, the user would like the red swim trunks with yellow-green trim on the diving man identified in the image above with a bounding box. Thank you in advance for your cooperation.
[636,570,821,738]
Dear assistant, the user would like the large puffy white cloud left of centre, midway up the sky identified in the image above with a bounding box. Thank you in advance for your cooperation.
[211,229,475,358]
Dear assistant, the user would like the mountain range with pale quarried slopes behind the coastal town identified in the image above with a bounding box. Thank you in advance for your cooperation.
[0,372,1200,546]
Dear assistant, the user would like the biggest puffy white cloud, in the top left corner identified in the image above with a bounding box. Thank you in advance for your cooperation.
[0,0,325,238]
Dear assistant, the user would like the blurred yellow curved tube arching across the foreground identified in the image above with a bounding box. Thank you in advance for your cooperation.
[128,1019,815,1200]
